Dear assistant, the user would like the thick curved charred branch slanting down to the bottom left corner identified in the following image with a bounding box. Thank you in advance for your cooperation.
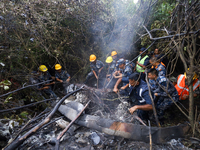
[4,86,83,150]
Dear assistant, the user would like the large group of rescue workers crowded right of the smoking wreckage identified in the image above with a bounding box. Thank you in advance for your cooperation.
[85,47,200,122]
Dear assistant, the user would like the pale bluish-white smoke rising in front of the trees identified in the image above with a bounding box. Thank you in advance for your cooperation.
[92,0,143,54]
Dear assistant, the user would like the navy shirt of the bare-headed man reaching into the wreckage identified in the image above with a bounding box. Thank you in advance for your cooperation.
[129,80,152,105]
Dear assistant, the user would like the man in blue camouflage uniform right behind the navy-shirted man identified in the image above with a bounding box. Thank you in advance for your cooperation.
[148,68,179,121]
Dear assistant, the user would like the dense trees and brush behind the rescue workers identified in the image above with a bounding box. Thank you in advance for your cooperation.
[0,0,200,142]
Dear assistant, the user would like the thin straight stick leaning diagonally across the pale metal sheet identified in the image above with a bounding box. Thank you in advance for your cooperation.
[55,100,91,150]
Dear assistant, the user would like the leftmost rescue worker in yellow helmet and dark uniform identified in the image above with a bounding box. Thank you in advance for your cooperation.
[38,65,57,98]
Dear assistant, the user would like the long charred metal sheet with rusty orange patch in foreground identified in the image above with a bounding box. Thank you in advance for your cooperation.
[59,103,189,144]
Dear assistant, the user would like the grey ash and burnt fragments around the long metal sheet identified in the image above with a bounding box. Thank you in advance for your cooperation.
[0,87,193,150]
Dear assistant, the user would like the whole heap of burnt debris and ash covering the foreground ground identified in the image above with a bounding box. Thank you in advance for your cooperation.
[0,85,195,150]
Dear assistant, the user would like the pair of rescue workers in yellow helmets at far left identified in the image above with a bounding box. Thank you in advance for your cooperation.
[34,64,71,99]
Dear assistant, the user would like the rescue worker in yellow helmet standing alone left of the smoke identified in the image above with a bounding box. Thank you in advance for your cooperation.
[84,54,104,84]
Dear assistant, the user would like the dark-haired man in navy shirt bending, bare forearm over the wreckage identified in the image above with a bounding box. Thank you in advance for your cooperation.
[129,72,153,120]
